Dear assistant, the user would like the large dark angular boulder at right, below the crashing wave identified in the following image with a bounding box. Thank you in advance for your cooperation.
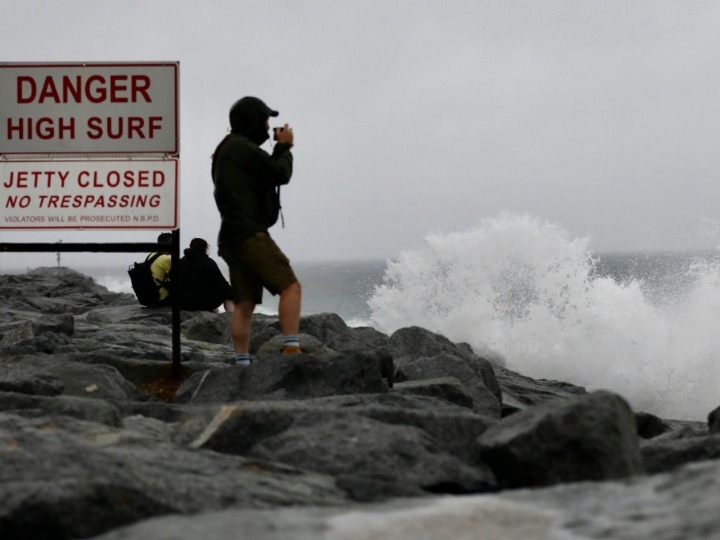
[478,390,643,488]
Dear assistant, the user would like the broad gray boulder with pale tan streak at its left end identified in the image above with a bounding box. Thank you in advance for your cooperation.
[186,400,495,500]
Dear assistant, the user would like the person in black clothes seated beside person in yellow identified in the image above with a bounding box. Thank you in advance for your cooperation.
[180,238,234,311]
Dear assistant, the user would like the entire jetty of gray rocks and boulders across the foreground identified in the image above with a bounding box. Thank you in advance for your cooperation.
[0,268,720,540]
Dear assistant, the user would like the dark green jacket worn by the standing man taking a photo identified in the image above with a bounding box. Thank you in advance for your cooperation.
[212,133,293,247]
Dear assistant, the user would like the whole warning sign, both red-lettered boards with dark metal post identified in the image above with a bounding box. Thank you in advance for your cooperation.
[0,62,180,375]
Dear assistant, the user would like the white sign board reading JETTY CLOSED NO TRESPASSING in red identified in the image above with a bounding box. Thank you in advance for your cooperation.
[0,158,179,230]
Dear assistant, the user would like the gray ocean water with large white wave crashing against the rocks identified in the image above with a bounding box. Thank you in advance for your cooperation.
[7,215,720,420]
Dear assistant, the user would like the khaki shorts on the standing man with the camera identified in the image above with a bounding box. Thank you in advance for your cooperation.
[219,232,297,304]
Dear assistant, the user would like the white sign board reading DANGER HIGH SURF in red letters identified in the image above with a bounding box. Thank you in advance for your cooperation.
[0,62,179,156]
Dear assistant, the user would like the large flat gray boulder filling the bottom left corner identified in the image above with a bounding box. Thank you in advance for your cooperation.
[0,413,345,540]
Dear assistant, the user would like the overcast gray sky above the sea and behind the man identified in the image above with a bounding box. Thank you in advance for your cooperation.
[0,0,720,265]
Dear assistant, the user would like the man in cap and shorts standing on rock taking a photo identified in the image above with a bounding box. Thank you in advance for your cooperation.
[212,96,302,365]
